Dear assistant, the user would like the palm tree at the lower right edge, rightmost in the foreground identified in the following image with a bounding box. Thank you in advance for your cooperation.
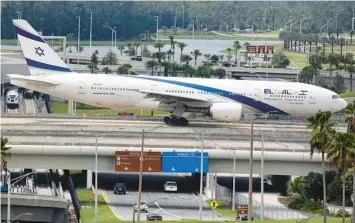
[327,132,355,223]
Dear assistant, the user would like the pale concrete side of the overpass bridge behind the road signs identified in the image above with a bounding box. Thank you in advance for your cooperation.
[8,145,332,176]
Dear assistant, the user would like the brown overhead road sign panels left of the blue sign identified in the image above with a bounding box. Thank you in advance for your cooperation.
[115,151,161,172]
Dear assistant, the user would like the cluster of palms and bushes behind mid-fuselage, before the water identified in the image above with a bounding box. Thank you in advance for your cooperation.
[88,36,230,79]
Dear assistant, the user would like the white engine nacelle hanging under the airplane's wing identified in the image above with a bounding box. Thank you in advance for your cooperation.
[209,102,242,122]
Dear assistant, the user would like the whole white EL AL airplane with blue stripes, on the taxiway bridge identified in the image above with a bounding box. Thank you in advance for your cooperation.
[8,20,347,126]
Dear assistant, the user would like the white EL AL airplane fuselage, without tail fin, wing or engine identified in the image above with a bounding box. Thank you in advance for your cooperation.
[11,73,344,115]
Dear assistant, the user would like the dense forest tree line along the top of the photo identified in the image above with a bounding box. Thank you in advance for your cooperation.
[1,1,355,40]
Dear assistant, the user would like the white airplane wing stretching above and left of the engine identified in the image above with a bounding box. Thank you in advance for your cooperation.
[138,90,209,102]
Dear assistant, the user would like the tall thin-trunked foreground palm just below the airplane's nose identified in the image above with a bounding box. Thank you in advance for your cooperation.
[307,111,334,223]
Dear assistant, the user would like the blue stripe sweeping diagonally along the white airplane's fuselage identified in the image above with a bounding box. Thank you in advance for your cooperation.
[128,75,288,115]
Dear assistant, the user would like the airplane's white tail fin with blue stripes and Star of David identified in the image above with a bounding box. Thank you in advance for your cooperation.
[12,19,72,75]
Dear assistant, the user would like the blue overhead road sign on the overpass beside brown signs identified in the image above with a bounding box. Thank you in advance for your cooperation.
[161,152,208,173]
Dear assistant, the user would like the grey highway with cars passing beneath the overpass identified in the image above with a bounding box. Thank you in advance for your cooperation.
[100,174,225,221]
